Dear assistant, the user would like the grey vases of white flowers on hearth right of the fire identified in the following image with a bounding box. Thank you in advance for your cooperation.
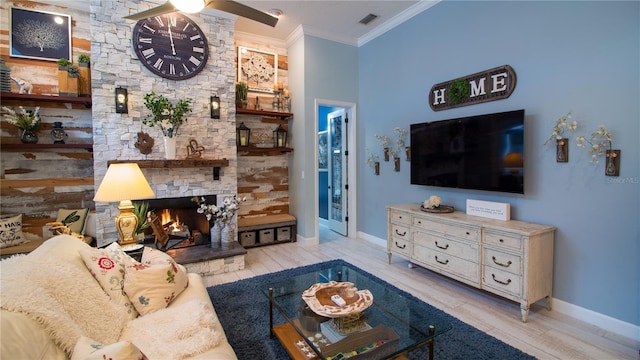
[195,195,247,248]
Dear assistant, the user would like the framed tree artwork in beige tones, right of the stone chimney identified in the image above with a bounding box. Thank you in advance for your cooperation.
[238,46,278,94]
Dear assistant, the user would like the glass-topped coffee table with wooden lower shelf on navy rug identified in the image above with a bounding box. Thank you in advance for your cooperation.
[263,265,451,360]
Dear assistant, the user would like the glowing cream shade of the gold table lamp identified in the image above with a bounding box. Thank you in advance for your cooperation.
[93,163,155,202]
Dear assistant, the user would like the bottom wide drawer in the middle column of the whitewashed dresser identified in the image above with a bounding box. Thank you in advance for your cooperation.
[412,244,480,286]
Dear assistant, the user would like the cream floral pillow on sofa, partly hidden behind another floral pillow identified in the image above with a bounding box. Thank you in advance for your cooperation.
[80,242,138,319]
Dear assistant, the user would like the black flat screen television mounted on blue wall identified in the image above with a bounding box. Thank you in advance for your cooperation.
[410,110,524,194]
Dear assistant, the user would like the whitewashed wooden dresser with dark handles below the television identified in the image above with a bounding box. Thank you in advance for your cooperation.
[387,204,555,322]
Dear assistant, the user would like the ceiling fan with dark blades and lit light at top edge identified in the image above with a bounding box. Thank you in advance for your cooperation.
[125,0,278,27]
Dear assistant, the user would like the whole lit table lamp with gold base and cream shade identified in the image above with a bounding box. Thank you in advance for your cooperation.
[93,163,155,246]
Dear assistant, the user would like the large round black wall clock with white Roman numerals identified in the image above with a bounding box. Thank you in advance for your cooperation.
[133,12,209,80]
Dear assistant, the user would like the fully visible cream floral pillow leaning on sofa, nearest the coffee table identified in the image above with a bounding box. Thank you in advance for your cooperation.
[124,247,189,315]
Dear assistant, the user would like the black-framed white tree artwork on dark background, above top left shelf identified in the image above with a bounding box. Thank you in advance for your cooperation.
[9,8,71,61]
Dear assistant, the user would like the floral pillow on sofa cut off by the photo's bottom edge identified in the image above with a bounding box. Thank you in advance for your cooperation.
[71,336,147,360]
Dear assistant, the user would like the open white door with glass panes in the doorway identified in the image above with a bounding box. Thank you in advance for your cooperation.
[327,109,348,236]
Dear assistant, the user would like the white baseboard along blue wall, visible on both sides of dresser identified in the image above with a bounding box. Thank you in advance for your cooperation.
[358,231,640,342]
